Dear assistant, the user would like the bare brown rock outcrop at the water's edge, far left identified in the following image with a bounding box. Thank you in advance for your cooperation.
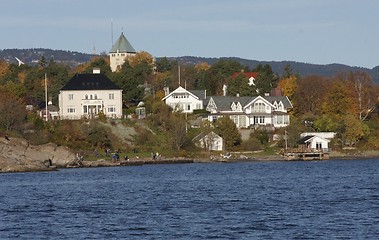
[0,138,75,172]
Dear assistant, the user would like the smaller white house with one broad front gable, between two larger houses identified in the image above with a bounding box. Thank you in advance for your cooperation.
[162,87,207,113]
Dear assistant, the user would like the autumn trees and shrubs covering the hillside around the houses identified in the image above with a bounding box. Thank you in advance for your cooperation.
[0,52,379,157]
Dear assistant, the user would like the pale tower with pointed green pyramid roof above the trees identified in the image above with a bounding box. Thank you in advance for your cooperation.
[109,33,136,72]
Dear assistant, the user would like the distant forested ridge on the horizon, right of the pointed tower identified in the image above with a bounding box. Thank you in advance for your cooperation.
[169,56,379,84]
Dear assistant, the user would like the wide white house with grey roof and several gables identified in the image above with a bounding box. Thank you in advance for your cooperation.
[206,96,293,128]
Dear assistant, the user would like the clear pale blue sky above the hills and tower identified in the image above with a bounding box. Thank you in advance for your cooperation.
[0,0,379,68]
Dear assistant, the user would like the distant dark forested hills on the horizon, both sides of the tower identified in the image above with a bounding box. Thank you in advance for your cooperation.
[0,48,379,84]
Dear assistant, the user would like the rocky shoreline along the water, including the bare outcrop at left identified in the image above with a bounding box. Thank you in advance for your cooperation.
[0,138,379,173]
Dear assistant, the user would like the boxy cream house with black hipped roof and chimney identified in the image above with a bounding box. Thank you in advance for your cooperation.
[59,69,122,119]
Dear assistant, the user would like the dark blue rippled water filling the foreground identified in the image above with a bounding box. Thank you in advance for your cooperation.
[0,159,379,239]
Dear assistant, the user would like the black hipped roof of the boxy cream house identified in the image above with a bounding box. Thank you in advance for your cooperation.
[61,74,120,90]
